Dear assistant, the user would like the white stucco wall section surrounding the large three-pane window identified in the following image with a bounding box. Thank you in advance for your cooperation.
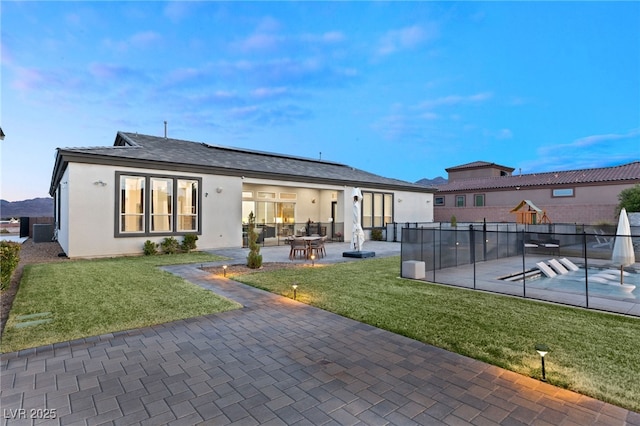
[58,163,242,258]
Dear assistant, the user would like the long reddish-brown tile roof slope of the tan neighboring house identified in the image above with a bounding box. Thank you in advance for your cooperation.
[437,161,640,192]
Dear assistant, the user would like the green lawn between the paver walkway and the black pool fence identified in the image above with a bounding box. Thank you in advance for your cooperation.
[233,257,640,411]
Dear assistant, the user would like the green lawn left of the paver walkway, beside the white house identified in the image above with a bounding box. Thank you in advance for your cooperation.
[2,252,240,352]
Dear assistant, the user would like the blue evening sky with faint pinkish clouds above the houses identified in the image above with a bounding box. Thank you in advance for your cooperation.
[0,1,640,201]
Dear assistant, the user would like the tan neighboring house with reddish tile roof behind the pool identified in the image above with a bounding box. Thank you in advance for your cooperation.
[434,161,640,224]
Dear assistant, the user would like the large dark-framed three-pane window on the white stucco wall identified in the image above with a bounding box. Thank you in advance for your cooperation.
[115,172,201,237]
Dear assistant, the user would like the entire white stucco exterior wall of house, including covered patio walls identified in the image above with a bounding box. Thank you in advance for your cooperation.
[58,163,433,258]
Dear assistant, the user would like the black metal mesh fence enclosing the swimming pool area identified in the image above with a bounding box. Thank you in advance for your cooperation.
[401,223,640,316]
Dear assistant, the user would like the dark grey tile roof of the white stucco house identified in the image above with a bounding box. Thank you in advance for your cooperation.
[52,132,435,192]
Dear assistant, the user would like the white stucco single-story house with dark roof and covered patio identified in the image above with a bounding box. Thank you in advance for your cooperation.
[49,132,435,257]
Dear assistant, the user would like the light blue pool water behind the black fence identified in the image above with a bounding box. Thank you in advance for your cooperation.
[527,268,640,299]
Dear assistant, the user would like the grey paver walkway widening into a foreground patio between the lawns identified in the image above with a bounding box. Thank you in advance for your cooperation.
[1,245,640,425]
